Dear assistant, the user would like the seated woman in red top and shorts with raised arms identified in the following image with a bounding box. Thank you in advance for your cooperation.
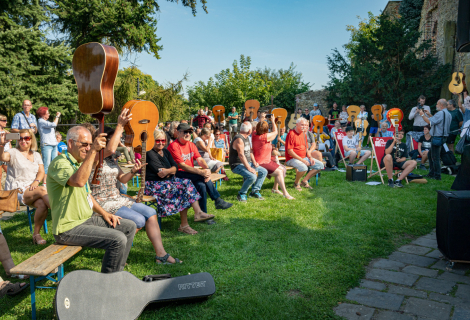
[253,121,295,200]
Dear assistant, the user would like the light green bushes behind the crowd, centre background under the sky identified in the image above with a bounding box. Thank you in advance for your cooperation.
[188,55,310,113]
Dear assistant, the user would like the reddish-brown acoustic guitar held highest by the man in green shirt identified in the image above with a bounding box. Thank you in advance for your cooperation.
[72,42,119,185]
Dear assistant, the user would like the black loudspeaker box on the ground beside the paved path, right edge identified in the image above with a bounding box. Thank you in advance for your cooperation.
[436,191,470,262]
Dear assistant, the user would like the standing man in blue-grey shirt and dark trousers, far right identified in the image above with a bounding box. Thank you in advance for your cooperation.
[419,99,452,180]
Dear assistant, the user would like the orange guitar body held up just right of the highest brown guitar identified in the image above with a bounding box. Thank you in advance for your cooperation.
[122,100,159,151]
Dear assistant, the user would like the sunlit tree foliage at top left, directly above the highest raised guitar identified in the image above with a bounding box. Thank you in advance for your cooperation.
[45,0,207,59]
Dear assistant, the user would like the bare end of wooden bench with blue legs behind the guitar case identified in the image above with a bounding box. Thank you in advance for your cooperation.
[10,244,82,320]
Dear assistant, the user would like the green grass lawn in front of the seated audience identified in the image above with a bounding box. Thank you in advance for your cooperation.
[0,165,454,319]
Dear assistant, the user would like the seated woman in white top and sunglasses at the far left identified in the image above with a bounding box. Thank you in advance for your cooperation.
[0,129,51,245]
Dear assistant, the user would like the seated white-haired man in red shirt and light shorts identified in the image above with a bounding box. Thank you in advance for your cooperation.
[286,118,325,191]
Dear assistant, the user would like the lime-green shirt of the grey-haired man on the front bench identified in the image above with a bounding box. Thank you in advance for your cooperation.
[47,153,93,235]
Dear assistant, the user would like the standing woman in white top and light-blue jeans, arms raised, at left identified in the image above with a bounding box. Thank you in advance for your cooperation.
[36,107,60,184]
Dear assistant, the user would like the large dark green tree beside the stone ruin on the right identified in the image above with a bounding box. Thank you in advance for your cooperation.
[327,15,450,129]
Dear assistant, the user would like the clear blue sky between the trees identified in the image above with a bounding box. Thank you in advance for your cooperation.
[120,0,388,94]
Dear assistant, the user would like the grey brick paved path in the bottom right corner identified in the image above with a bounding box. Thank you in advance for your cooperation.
[335,231,470,320]
